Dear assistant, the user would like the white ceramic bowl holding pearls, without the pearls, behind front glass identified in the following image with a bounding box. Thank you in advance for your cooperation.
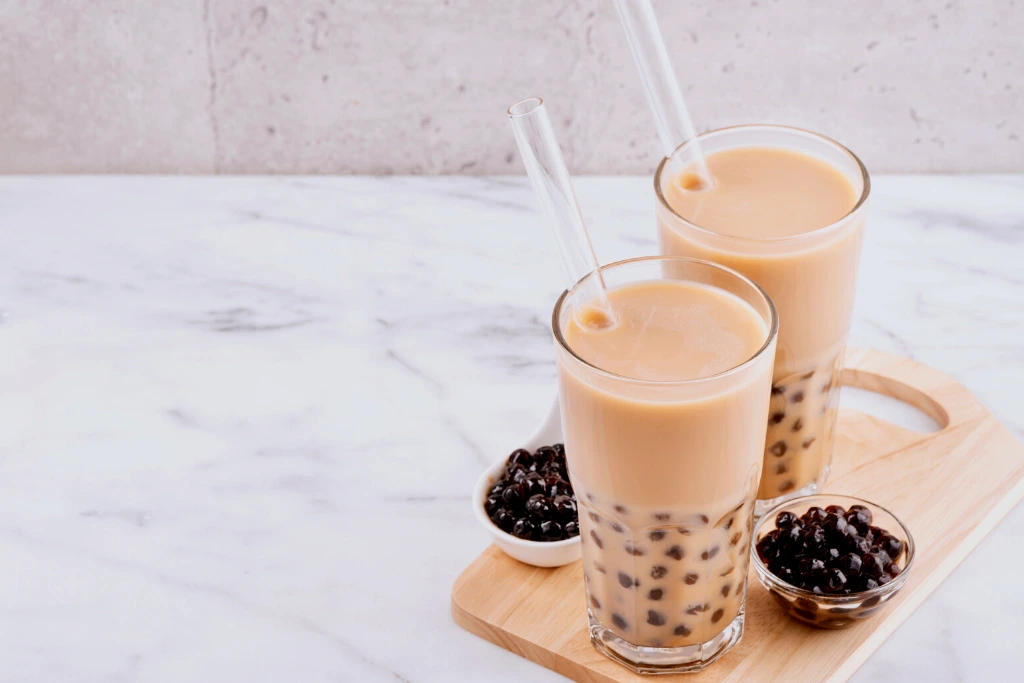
[473,395,582,567]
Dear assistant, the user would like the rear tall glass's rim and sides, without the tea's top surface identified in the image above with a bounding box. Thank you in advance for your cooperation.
[654,125,870,515]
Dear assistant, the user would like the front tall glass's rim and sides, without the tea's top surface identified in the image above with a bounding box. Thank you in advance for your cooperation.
[552,257,778,673]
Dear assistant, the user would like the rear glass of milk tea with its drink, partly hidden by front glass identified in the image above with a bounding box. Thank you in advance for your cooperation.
[655,126,868,507]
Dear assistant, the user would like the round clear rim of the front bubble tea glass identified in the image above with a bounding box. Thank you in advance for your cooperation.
[551,256,778,387]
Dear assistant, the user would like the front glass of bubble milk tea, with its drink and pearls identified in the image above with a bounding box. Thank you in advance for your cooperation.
[552,257,778,673]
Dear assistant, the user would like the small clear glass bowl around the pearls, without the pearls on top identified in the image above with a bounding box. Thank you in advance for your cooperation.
[751,494,913,629]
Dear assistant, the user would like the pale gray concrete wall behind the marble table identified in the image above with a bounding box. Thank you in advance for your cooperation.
[0,0,1024,174]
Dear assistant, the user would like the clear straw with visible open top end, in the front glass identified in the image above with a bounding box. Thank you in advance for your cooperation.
[508,97,615,327]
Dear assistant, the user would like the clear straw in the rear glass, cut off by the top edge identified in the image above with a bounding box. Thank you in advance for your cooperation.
[614,0,712,187]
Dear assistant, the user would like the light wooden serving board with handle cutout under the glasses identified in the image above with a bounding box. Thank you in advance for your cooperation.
[452,349,1024,683]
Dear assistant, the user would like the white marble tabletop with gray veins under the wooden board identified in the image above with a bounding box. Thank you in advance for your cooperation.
[0,176,1024,683]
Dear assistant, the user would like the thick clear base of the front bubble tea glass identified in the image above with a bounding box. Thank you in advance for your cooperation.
[587,607,743,674]
